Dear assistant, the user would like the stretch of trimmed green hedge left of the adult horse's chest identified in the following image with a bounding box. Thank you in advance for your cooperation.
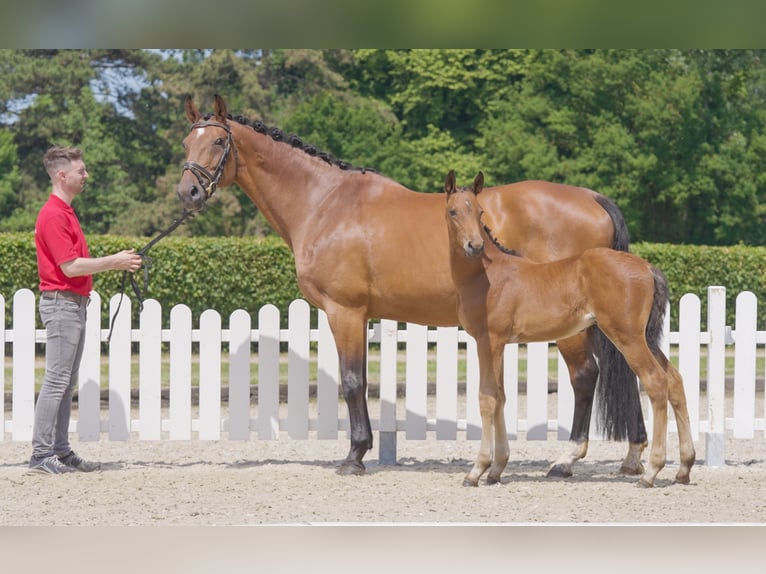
[0,233,301,324]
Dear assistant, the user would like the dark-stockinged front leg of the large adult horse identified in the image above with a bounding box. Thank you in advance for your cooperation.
[327,309,372,475]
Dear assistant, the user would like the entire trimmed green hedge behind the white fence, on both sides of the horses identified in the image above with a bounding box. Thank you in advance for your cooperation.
[0,233,766,329]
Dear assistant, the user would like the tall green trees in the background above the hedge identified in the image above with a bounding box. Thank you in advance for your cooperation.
[0,49,766,245]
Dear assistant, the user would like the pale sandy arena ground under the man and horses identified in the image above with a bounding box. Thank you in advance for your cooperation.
[0,431,766,526]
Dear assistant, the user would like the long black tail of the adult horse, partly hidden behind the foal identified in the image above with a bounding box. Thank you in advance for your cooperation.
[593,194,648,443]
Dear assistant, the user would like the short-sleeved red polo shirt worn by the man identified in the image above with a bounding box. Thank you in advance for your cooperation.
[35,195,93,297]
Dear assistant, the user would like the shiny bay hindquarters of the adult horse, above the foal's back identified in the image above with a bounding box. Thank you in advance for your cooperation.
[479,180,615,261]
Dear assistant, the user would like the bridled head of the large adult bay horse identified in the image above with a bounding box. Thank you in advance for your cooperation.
[176,95,237,211]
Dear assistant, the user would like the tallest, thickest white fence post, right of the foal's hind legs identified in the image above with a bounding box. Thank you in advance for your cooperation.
[705,286,726,466]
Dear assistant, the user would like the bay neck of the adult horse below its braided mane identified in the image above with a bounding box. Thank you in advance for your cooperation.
[235,127,342,248]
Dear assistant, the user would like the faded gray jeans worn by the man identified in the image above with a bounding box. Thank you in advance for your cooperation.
[32,298,87,459]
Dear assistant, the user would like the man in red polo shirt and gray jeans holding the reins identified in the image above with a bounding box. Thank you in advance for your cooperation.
[29,146,141,474]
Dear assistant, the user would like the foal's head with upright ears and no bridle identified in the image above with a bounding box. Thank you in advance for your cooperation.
[444,171,484,257]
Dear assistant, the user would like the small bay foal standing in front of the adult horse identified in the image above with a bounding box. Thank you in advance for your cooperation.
[444,171,695,487]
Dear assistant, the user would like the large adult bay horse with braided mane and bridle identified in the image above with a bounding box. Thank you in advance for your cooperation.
[177,95,647,476]
